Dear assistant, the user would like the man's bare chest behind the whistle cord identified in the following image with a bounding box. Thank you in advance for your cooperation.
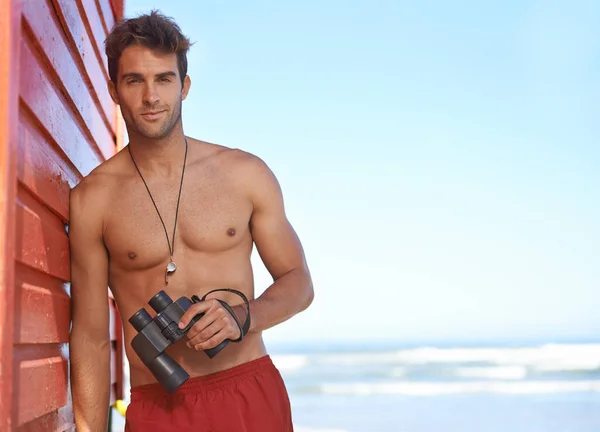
[105,171,252,270]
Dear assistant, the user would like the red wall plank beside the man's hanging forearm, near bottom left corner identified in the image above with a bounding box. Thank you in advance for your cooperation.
[13,344,69,426]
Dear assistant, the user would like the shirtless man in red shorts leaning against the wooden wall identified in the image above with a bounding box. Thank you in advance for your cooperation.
[69,12,313,432]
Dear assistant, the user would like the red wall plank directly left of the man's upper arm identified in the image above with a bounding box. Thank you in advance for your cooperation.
[15,187,70,281]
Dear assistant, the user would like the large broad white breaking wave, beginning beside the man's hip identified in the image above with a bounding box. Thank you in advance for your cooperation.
[272,344,600,384]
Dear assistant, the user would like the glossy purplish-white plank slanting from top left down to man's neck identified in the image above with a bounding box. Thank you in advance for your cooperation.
[23,1,115,143]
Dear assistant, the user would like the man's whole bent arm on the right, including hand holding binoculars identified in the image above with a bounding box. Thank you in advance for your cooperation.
[179,154,314,351]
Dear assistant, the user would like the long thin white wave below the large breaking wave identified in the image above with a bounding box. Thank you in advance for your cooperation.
[316,380,600,396]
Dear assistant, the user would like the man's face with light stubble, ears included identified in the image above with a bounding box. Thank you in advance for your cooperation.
[109,45,190,139]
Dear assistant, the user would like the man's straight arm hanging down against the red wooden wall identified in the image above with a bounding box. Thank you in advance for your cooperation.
[69,180,110,432]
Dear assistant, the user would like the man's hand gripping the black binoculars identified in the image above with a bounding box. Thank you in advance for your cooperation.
[179,299,241,351]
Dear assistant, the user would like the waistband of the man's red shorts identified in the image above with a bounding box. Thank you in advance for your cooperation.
[131,355,275,401]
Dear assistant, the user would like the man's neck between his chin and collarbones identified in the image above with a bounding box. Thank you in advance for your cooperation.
[128,130,186,178]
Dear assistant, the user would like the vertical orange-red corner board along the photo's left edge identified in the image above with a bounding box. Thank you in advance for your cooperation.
[0,0,21,431]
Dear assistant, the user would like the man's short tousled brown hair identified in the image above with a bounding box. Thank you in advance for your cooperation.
[104,10,191,85]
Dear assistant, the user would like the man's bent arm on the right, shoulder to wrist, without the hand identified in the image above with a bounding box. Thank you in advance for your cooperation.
[247,156,314,331]
